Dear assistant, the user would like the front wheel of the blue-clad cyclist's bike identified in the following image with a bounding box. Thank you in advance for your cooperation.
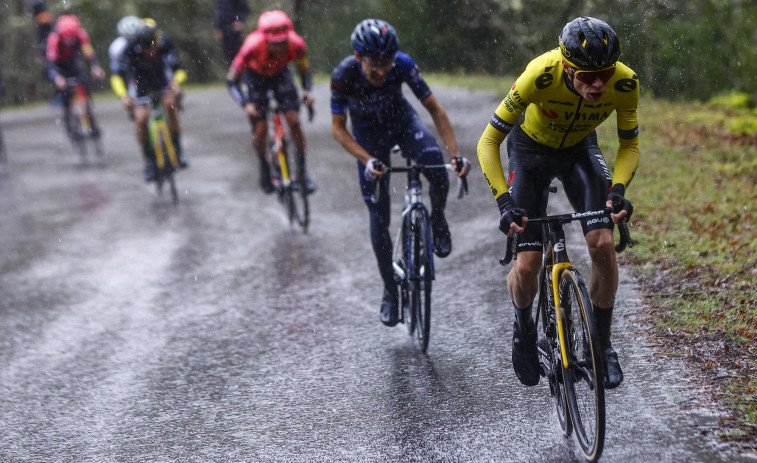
[413,209,432,352]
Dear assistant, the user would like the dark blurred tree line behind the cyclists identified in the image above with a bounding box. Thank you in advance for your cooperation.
[0,0,757,102]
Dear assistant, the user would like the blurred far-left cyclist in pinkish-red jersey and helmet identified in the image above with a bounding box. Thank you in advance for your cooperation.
[46,15,105,137]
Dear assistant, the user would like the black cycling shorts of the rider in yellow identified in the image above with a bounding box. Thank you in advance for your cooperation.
[507,125,613,252]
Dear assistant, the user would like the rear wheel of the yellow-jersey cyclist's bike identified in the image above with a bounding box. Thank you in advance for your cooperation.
[534,266,573,437]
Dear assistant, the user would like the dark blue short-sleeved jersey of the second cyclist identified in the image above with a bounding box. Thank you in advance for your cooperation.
[331,52,431,127]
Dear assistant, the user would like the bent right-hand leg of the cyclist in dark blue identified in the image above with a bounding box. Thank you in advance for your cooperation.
[399,110,452,257]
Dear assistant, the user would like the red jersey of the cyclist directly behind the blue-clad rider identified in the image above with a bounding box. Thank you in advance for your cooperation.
[231,30,308,77]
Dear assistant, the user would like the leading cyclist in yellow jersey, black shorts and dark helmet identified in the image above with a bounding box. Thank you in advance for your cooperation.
[478,17,639,388]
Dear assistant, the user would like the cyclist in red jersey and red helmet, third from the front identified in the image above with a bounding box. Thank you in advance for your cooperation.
[226,10,316,193]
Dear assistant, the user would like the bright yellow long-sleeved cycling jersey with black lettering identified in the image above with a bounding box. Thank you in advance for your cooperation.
[478,48,639,196]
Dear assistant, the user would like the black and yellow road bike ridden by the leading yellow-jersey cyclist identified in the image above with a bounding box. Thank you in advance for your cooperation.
[500,186,633,462]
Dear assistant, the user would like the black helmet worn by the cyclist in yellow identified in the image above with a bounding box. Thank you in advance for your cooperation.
[560,16,620,70]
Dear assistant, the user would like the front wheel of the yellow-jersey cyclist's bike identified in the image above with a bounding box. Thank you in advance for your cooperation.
[558,267,605,462]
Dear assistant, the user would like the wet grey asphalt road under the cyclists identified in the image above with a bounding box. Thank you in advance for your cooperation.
[0,84,734,462]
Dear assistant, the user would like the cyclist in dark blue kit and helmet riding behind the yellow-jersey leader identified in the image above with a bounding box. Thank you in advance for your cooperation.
[331,19,470,326]
